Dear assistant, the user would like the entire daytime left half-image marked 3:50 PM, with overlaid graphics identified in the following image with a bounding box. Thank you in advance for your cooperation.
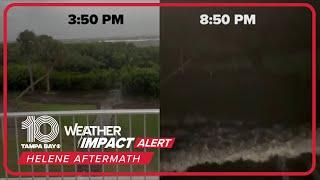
[1,6,160,177]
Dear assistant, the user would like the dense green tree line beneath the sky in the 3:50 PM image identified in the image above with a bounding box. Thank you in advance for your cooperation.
[1,30,160,97]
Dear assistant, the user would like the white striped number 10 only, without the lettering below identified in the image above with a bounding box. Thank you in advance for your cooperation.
[21,115,59,143]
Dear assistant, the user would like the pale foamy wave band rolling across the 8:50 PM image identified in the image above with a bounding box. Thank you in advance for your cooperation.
[161,127,319,171]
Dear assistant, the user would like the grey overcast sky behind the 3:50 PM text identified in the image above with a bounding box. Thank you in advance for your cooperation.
[0,1,159,41]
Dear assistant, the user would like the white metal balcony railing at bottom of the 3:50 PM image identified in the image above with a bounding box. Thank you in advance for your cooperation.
[0,109,160,179]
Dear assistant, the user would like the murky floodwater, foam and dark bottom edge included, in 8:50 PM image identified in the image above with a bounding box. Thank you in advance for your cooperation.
[161,121,311,171]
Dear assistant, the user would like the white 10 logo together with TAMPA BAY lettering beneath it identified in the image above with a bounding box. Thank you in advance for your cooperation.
[21,115,61,149]
